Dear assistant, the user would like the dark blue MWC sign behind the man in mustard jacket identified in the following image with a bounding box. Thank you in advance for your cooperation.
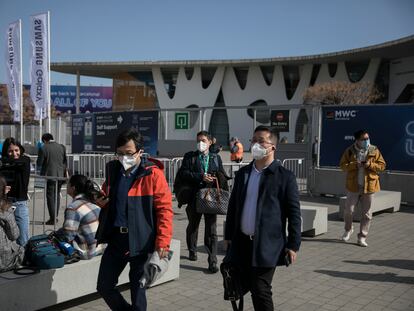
[319,105,414,171]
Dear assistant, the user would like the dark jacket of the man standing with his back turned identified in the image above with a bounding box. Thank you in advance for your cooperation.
[37,141,68,177]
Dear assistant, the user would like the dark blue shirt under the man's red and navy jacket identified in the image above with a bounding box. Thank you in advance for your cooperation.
[114,165,139,227]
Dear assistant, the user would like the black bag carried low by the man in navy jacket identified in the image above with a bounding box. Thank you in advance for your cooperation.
[220,262,248,311]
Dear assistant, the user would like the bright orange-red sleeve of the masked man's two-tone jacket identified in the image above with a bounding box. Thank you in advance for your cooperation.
[152,169,174,249]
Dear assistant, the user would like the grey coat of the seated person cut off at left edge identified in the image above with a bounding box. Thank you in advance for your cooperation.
[0,209,24,272]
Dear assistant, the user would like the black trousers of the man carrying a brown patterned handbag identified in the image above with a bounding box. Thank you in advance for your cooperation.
[185,203,217,264]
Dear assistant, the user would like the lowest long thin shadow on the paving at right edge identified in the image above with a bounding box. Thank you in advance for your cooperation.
[314,270,414,284]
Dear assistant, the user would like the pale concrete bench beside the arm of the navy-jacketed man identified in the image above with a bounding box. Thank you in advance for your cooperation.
[300,203,328,236]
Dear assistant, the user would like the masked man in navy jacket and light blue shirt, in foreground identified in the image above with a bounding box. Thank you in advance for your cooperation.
[225,125,301,311]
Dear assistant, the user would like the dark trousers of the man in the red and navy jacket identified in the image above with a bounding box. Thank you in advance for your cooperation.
[97,233,148,311]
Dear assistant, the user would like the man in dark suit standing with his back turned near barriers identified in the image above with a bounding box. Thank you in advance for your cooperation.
[37,133,68,225]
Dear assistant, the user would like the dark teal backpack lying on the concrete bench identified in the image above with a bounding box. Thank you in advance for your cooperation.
[26,234,65,269]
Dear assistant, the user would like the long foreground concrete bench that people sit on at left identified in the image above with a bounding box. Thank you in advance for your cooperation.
[0,240,180,311]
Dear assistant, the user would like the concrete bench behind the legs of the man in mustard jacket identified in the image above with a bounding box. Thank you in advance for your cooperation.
[339,190,401,221]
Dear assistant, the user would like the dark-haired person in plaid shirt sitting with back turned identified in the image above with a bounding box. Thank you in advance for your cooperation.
[58,175,103,259]
